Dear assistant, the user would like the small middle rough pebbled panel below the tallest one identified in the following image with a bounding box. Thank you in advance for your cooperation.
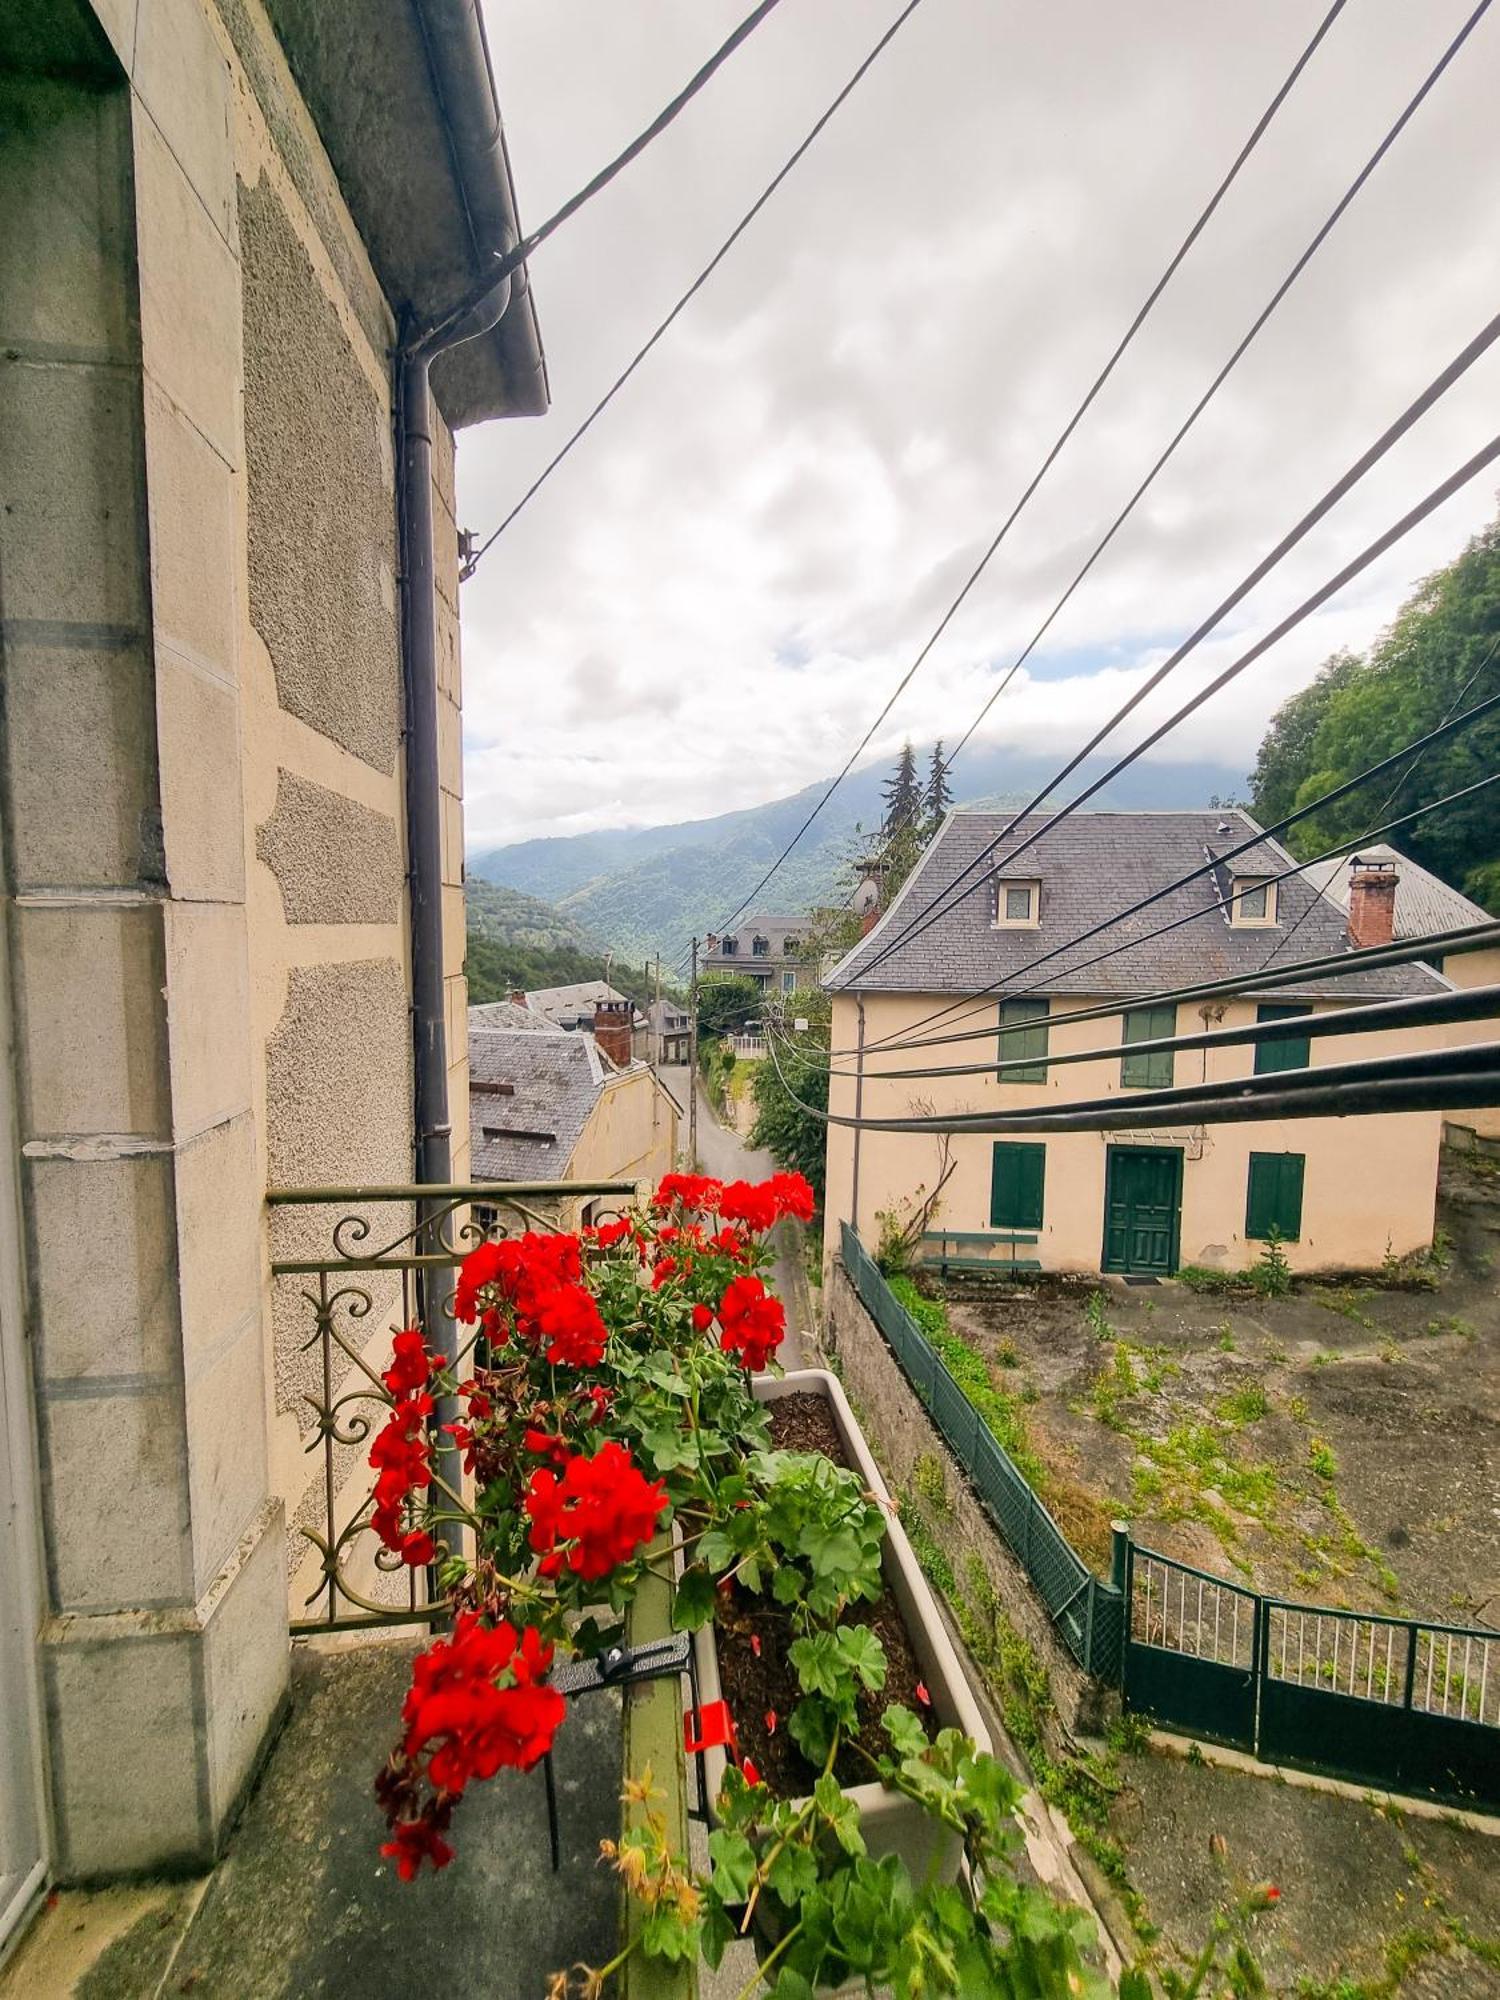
[256,770,402,924]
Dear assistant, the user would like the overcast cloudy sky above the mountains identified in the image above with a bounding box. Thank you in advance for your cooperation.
[458,0,1500,850]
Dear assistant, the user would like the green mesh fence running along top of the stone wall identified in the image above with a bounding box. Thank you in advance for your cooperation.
[842,1222,1126,1682]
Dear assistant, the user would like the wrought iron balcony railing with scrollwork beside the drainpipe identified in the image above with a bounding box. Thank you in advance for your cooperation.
[266,1180,640,1632]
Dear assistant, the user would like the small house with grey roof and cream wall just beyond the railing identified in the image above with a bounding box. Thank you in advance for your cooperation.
[468,1002,678,1222]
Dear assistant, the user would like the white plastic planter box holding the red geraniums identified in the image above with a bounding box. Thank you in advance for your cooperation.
[692,1368,994,1882]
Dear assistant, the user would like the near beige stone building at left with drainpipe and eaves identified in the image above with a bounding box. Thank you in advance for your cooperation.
[0,0,546,1940]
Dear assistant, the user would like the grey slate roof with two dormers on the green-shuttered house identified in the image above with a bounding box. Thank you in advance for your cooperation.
[826,808,1448,1000]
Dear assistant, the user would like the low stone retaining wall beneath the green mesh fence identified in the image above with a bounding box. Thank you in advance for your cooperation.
[822,1262,1110,1730]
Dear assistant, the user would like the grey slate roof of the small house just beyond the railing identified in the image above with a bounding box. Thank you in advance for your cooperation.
[468,1008,620,1180]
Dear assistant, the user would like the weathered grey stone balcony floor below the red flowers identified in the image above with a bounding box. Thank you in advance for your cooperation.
[0,1634,622,2000]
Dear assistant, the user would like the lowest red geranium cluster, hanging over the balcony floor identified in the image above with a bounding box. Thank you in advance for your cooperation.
[380,1612,566,1882]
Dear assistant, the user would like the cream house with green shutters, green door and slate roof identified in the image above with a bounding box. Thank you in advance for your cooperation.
[826,812,1472,1276]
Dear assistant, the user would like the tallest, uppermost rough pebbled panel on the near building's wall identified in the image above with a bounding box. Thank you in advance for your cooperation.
[240,180,402,772]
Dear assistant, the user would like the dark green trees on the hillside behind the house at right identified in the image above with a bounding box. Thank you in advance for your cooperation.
[1252,508,1500,910]
